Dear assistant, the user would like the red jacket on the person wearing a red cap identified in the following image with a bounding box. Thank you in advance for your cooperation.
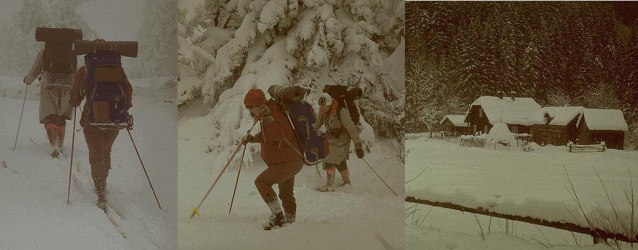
[253,101,303,166]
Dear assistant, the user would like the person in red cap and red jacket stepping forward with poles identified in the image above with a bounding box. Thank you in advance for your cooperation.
[242,89,304,230]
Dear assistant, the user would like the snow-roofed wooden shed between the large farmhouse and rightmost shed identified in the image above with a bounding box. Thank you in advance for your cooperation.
[530,106,584,145]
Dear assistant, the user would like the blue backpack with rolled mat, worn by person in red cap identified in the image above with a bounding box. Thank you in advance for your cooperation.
[268,85,328,165]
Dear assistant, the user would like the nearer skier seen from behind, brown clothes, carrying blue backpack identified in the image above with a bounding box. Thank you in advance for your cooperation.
[70,39,137,211]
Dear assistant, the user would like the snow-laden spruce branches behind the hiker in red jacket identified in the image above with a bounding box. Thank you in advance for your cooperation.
[178,0,404,152]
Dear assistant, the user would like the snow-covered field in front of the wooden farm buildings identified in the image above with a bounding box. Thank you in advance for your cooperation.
[406,138,638,249]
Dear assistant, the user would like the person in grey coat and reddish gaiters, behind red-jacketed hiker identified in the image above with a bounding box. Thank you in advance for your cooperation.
[313,93,364,192]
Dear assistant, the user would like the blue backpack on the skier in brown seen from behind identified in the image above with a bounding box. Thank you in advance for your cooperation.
[84,51,133,129]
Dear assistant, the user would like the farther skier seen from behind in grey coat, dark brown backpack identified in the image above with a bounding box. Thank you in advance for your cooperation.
[22,27,82,158]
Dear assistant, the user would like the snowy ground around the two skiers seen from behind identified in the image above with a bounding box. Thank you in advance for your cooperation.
[0,77,177,249]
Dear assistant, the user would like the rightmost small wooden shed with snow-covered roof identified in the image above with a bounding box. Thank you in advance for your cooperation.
[576,109,628,150]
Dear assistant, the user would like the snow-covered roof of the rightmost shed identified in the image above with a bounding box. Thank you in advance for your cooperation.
[578,109,628,131]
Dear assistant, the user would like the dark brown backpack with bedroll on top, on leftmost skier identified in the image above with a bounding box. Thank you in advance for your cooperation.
[35,27,82,74]
